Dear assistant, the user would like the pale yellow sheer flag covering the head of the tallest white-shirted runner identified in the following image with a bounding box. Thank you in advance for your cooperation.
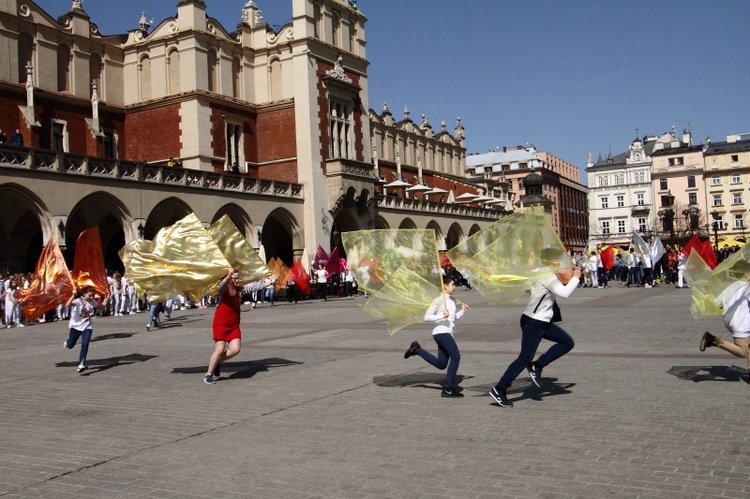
[447,206,573,305]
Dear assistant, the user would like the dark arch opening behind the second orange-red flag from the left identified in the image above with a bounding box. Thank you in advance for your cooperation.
[65,192,135,272]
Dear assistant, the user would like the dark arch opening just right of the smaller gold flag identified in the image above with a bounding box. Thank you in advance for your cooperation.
[258,208,305,267]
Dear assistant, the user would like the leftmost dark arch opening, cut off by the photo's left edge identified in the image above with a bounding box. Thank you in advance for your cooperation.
[0,183,50,273]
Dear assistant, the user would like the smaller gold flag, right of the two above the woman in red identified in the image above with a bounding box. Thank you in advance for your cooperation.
[208,215,271,288]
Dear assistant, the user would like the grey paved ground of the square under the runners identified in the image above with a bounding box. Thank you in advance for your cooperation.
[0,283,750,498]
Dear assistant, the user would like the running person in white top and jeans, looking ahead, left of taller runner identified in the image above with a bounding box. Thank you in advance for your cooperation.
[404,277,469,397]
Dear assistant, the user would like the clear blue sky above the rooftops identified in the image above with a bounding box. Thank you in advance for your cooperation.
[36,0,750,184]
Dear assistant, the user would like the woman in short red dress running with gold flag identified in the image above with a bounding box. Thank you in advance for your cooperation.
[203,267,242,385]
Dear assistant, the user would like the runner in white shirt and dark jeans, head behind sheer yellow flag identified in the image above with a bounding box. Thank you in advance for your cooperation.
[490,248,581,407]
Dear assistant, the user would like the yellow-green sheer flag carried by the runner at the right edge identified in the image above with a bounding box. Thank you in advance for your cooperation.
[685,246,750,319]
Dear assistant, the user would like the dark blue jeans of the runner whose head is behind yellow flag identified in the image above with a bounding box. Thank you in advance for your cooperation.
[496,314,575,390]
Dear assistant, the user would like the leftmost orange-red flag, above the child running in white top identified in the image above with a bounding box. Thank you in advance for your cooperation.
[19,236,75,320]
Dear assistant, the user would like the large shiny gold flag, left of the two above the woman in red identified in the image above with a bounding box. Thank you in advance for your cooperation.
[120,213,229,302]
